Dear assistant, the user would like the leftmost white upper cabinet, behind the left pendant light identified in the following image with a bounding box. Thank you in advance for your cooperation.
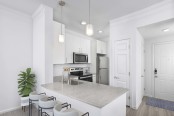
[53,21,66,64]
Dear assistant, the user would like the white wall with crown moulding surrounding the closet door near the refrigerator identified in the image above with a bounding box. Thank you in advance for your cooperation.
[110,0,174,109]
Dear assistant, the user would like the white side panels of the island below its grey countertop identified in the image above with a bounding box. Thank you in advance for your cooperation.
[43,88,126,116]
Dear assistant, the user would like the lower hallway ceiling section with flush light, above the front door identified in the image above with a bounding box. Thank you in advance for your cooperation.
[139,19,174,39]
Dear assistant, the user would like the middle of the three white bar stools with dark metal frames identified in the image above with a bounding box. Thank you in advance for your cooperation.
[38,96,68,116]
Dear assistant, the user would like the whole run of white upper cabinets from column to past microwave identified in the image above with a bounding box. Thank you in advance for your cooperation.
[53,21,91,64]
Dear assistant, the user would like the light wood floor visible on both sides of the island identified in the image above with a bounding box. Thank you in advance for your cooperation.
[0,97,174,116]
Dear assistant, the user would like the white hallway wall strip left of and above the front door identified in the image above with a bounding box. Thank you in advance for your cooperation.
[145,35,174,96]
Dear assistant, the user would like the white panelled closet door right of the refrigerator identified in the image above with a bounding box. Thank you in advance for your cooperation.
[114,40,130,106]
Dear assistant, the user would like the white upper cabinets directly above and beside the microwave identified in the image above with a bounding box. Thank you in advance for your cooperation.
[66,32,91,63]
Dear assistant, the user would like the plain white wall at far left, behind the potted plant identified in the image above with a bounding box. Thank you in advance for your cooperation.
[0,6,32,112]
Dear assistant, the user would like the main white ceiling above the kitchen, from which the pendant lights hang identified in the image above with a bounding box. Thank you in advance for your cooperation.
[0,0,163,39]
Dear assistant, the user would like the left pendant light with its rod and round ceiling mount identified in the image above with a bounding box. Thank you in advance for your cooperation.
[59,0,65,43]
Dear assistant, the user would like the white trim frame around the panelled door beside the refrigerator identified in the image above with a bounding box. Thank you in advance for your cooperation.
[113,38,130,107]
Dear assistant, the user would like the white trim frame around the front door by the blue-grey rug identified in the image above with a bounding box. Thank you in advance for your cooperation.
[151,41,174,97]
